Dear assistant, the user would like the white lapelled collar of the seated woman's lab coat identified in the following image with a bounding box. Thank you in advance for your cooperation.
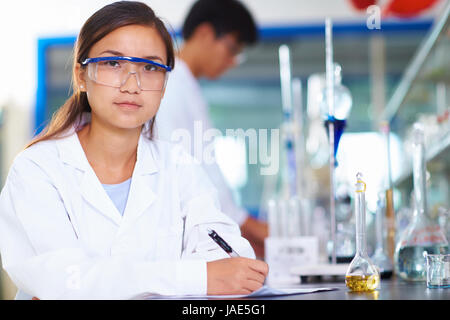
[57,114,158,229]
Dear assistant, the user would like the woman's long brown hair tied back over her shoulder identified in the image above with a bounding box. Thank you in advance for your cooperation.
[27,1,175,148]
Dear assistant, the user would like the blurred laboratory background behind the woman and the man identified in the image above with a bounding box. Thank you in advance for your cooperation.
[0,0,450,299]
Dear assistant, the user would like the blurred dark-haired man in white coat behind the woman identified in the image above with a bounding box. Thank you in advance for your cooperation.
[156,0,268,258]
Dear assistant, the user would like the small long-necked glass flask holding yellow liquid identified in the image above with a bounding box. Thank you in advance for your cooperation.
[345,173,380,292]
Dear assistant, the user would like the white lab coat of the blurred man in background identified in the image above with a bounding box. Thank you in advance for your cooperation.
[155,59,248,225]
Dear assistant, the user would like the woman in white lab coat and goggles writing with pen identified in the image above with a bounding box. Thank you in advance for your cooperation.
[0,1,268,299]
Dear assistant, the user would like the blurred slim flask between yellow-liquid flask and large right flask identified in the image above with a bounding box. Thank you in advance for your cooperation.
[371,192,394,279]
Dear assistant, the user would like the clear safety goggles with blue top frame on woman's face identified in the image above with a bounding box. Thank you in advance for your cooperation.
[81,56,172,91]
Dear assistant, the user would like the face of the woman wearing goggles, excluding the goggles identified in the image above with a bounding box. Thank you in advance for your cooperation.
[76,25,167,129]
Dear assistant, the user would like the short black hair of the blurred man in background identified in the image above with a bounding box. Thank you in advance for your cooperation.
[183,0,258,44]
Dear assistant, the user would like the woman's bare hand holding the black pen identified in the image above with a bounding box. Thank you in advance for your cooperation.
[207,257,269,295]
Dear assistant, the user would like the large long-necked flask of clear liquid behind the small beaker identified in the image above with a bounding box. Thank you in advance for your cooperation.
[394,123,448,281]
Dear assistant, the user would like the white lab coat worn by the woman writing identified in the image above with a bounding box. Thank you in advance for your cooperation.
[0,115,254,299]
